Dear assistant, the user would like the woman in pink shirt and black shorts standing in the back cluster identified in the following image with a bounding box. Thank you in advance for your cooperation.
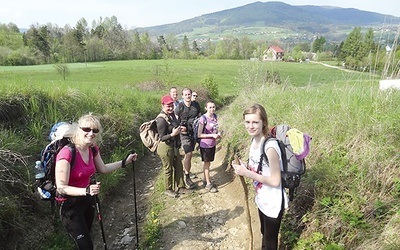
[197,100,221,193]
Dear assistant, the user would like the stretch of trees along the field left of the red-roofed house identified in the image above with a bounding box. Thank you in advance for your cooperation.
[0,16,266,66]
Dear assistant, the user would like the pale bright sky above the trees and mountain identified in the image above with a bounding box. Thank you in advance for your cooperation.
[0,0,400,28]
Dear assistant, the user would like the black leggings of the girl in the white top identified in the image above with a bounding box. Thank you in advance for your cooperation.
[258,209,283,250]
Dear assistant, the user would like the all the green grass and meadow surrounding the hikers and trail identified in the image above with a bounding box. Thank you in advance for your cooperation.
[0,60,400,249]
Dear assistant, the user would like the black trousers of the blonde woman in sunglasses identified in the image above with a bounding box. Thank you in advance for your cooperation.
[59,196,95,250]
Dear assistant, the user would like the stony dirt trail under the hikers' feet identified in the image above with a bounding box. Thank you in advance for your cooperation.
[93,146,260,250]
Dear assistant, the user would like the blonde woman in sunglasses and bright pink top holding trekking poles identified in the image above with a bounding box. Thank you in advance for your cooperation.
[55,114,137,250]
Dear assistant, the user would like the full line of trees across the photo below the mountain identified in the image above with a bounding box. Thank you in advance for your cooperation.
[0,16,400,73]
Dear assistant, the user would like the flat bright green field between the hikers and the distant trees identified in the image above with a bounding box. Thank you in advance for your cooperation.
[0,60,376,96]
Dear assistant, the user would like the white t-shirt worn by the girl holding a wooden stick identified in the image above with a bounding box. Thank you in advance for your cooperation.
[249,140,288,218]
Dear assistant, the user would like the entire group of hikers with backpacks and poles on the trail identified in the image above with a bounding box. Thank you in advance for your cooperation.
[34,88,311,249]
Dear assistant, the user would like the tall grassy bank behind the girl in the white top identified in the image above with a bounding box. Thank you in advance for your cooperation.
[221,66,400,249]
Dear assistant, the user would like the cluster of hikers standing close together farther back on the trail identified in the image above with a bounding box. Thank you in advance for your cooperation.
[155,87,221,198]
